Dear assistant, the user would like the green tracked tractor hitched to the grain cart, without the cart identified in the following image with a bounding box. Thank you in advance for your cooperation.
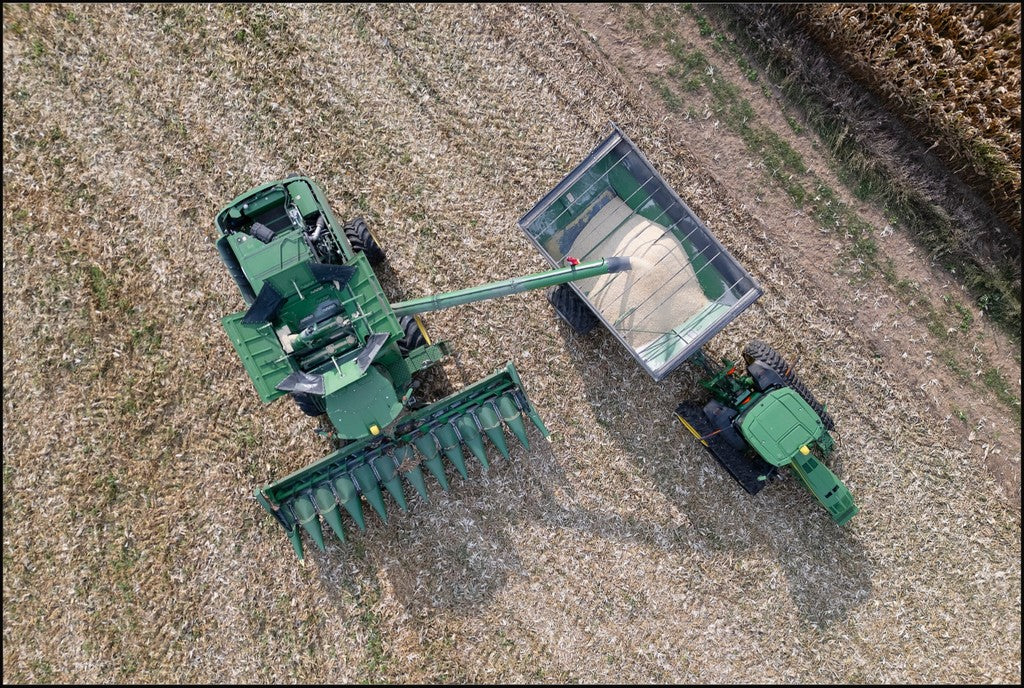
[676,340,859,525]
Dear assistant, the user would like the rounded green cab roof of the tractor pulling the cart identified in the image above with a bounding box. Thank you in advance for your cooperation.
[739,387,825,466]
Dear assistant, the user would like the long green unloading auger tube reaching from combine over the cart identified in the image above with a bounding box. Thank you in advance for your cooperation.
[391,256,632,317]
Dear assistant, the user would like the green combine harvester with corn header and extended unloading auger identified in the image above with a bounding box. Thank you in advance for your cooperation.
[216,175,630,561]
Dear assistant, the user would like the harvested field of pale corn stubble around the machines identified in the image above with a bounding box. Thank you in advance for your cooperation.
[3,4,1021,683]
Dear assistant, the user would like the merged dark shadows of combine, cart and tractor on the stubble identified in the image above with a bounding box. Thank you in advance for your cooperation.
[313,318,872,627]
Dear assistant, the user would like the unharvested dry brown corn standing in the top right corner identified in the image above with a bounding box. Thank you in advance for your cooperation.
[793,4,1021,232]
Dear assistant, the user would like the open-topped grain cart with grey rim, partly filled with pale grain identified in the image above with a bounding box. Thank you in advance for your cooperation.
[519,125,762,380]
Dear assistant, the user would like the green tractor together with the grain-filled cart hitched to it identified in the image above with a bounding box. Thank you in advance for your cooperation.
[519,125,857,524]
